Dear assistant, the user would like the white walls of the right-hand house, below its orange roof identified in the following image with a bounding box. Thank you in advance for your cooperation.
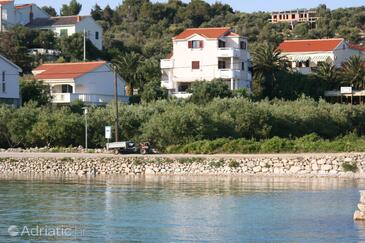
[279,40,365,74]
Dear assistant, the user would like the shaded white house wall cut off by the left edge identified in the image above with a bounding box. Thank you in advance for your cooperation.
[0,55,22,106]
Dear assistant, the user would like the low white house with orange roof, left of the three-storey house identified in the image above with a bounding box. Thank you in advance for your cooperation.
[32,61,128,105]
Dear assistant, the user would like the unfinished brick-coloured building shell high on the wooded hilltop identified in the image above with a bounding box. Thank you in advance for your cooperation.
[271,9,318,26]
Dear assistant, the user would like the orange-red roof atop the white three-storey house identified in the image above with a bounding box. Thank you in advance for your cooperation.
[174,27,239,40]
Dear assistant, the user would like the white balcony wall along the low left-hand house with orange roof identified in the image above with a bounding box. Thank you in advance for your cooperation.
[52,93,128,105]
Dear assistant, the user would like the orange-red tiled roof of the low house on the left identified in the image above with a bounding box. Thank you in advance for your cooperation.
[33,61,106,79]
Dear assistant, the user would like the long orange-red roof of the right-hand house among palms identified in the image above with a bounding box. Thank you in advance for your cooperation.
[278,39,343,52]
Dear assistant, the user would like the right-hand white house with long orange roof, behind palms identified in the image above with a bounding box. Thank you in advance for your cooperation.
[278,38,365,74]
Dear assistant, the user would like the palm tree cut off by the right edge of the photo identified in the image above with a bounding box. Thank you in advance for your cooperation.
[340,56,365,90]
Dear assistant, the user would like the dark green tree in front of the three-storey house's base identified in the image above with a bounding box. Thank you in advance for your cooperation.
[189,79,233,104]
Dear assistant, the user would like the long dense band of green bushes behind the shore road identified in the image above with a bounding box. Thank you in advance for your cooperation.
[0,98,365,150]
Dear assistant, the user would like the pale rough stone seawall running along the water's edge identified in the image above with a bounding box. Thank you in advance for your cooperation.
[0,154,365,178]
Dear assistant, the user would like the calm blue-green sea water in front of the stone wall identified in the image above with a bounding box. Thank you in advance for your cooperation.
[0,177,365,242]
